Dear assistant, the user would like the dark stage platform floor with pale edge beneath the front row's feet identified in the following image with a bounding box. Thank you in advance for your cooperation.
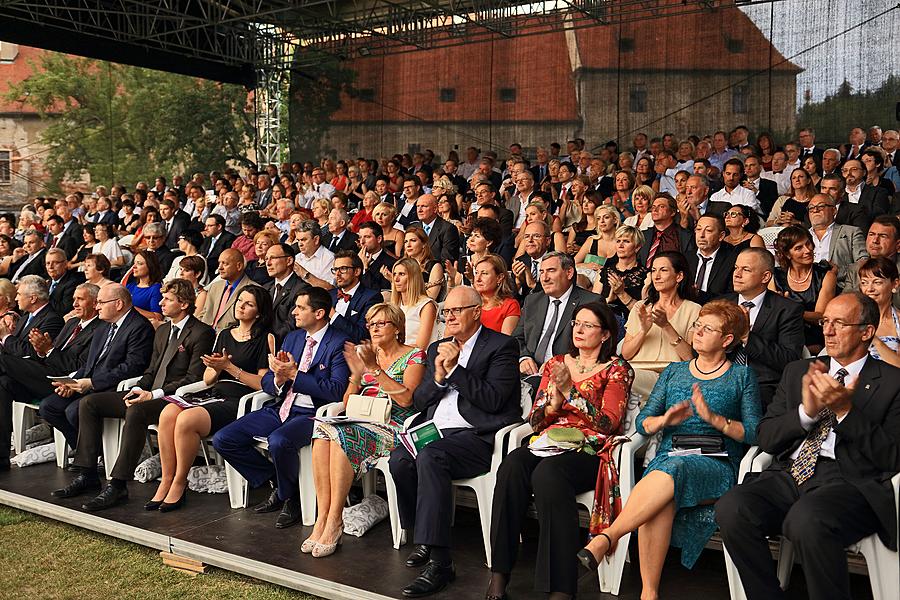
[0,464,871,600]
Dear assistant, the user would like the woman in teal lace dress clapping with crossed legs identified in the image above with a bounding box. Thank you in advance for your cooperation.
[578,300,761,600]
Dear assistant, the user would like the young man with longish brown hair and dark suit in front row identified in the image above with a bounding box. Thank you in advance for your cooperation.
[53,279,215,511]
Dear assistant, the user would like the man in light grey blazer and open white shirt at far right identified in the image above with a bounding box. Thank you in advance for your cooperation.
[809,194,868,289]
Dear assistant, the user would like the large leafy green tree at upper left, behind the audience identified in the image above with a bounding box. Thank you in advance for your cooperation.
[7,52,254,187]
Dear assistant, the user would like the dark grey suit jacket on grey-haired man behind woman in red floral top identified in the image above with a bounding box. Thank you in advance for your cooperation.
[513,285,603,364]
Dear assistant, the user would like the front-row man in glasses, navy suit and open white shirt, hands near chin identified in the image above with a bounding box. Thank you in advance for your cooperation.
[389,286,522,597]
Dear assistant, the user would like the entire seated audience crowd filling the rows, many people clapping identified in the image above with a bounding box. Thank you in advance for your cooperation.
[0,126,900,600]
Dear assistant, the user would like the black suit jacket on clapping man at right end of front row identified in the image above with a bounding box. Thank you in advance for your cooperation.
[757,357,900,551]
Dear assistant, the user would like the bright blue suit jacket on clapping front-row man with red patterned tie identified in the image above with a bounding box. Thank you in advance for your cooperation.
[262,327,350,408]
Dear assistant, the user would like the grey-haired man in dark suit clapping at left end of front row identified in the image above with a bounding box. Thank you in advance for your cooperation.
[0,283,100,470]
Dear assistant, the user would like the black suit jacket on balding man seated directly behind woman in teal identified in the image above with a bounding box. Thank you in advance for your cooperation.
[723,291,804,408]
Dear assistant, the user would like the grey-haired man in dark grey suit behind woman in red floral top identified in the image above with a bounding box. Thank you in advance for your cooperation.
[513,252,602,378]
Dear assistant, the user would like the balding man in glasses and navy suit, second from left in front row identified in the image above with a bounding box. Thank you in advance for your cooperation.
[40,283,153,448]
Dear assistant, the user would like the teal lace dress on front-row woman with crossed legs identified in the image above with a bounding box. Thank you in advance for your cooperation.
[637,362,761,568]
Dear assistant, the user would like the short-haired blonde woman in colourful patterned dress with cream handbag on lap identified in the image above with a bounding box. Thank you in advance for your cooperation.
[300,304,425,558]
